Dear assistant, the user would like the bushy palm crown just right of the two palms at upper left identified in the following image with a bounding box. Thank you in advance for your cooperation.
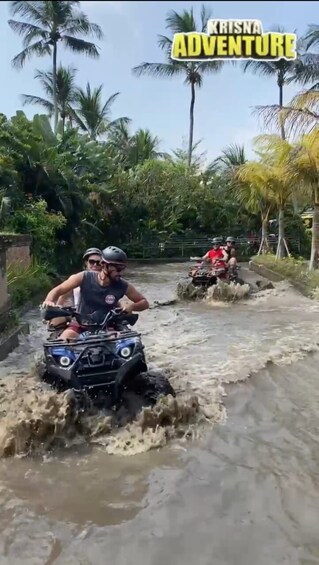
[74,83,130,139]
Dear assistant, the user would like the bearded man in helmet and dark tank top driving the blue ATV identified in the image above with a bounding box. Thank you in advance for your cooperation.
[43,246,149,339]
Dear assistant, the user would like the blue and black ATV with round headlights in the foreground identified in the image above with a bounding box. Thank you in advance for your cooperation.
[42,306,176,407]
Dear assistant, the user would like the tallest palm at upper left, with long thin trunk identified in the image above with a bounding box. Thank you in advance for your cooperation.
[8,0,103,131]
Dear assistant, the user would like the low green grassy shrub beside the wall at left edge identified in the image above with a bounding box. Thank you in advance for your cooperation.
[7,262,53,309]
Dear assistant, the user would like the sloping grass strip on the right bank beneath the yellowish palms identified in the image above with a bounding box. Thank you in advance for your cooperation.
[251,254,319,298]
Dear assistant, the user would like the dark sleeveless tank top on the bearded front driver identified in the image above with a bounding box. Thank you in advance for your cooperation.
[77,271,128,317]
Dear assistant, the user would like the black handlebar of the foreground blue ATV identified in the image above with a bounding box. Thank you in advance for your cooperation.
[43,306,139,329]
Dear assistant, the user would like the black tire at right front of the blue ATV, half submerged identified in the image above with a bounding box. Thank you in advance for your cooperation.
[130,371,176,404]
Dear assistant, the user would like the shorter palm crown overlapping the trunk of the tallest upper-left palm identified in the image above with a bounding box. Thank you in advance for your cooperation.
[22,66,76,132]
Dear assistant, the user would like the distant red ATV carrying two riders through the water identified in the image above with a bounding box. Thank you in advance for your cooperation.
[188,257,240,288]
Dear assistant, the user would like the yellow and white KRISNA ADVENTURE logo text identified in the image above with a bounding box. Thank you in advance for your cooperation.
[171,19,297,61]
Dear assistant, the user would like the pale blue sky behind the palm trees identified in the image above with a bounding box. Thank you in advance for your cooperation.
[0,0,319,160]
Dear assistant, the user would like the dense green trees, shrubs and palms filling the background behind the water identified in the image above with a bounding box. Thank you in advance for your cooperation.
[0,0,319,290]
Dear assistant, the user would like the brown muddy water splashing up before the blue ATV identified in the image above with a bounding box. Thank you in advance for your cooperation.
[0,356,205,457]
